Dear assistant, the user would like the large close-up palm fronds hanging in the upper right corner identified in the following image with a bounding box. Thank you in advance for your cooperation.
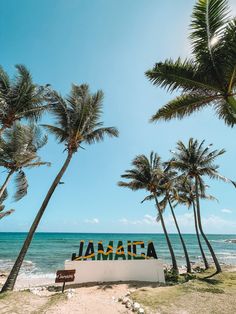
[146,0,236,127]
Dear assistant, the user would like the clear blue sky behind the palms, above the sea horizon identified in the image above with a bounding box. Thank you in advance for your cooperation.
[0,0,236,234]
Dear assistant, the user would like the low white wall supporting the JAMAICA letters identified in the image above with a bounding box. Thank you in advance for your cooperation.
[65,259,165,283]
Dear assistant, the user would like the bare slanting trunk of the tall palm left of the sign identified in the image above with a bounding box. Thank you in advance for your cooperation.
[1,153,72,293]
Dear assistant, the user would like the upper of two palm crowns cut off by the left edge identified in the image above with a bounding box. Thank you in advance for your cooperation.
[0,65,48,134]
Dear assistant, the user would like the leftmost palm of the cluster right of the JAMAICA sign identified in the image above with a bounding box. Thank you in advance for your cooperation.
[118,152,178,272]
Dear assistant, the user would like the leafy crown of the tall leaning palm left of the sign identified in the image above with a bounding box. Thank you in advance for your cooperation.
[43,84,118,154]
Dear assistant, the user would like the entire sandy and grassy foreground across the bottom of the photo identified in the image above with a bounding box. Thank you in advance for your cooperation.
[0,267,236,314]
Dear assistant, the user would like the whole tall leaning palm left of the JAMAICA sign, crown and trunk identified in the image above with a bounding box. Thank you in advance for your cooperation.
[1,84,118,292]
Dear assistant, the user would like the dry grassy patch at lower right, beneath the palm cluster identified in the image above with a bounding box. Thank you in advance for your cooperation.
[131,270,236,314]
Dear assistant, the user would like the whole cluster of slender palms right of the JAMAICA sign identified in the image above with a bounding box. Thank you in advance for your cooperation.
[118,138,236,273]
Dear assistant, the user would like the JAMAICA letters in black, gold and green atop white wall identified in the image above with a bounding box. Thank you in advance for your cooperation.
[71,240,157,261]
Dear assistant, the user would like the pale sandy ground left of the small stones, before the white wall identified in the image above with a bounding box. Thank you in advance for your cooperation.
[0,274,135,314]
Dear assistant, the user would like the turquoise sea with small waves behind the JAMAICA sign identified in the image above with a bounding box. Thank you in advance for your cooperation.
[0,233,236,274]
